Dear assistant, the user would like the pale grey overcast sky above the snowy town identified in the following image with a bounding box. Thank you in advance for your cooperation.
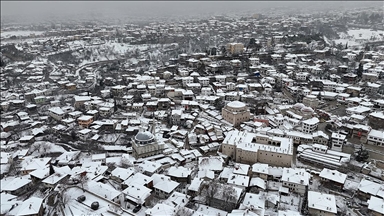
[1,0,383,22]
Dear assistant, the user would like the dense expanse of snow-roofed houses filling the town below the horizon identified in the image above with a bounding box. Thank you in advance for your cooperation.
[0,6,384,216]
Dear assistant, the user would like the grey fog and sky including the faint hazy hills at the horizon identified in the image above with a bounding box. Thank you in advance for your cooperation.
[1,1,384,22]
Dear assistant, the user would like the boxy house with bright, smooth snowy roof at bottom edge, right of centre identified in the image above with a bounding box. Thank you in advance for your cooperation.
[308,191,337,216]
